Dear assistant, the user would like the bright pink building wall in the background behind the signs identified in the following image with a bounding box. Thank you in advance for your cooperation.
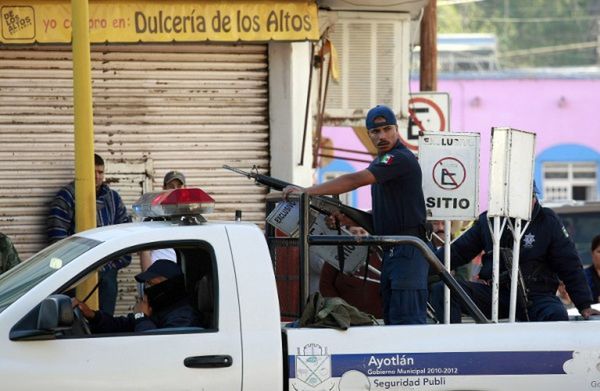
[323,78,600,210]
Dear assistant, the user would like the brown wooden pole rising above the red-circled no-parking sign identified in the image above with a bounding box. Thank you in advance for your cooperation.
[419,0,437,91]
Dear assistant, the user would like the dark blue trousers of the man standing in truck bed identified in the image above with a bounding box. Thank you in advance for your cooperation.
[380,245,429,325]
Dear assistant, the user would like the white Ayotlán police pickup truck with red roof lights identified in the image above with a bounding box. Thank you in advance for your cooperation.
[0,189,600,391]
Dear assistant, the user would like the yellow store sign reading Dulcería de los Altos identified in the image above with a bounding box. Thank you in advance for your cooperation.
[0,0,319,44]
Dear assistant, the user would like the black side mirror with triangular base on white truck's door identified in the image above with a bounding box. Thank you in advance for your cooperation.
[9,295,74,341]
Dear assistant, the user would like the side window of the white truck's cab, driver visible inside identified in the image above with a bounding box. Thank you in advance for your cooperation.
[8,244,217,338]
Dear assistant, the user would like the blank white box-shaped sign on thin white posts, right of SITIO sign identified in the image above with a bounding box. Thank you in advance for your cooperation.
[488,128,535,322]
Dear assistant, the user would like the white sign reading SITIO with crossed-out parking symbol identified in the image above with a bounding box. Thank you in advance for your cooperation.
[419,132,479,220]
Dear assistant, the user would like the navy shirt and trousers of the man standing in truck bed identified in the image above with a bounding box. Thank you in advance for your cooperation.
[367,141,429,324]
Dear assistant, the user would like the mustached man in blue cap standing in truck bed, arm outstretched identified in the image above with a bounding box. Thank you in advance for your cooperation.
[283,105,429,324]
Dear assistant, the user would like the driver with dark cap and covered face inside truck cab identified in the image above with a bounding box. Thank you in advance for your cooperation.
[74,259,200,333]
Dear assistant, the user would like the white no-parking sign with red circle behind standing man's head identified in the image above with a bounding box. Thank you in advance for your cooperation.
[399,92,450,152]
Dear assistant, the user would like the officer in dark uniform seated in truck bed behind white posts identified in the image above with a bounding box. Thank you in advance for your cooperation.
[430,193,600,323]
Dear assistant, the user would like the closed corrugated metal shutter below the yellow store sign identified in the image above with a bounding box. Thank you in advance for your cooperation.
[0,43,269,258]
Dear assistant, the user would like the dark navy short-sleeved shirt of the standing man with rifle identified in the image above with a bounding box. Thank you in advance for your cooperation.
[367,141,425,235]
